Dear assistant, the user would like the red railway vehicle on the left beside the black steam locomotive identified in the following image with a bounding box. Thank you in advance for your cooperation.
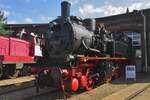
[0,31,41,78]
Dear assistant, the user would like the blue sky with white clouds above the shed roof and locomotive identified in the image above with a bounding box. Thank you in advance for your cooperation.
[0,0,150,23]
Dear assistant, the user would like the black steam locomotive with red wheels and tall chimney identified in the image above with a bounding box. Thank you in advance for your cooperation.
[36,1,132,92]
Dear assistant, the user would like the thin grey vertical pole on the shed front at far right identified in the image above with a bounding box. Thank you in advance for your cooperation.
[141,11,148,72]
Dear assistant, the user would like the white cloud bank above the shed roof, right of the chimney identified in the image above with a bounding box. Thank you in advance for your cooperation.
[79,0,150,17]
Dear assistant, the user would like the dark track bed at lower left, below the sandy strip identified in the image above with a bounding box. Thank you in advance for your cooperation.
[0,81,62,100]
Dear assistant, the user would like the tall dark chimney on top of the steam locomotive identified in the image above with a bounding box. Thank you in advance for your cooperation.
[61,1,71,18]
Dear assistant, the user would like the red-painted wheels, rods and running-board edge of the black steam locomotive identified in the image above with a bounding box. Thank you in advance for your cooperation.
[51,56,128,92]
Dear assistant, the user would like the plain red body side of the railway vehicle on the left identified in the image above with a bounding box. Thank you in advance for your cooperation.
[0,36,34,62]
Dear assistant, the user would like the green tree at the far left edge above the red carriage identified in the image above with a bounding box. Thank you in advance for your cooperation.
[0,10,12,36]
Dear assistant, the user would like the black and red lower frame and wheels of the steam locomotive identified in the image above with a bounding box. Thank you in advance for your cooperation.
[36,55,129,92]
